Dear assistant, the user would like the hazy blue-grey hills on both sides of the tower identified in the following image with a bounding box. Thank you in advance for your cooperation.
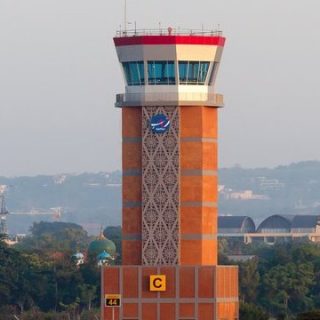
[0,161,320,233]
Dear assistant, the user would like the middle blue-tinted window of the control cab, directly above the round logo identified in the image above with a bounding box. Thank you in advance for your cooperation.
[148,61,176,85]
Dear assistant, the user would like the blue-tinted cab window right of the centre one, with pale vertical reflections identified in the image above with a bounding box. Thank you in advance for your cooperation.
[179,61,210,85]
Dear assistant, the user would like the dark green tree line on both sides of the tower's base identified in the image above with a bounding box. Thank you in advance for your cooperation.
[0,222,320,320]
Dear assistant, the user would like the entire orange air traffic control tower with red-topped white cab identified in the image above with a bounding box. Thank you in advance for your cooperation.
[102,28,238,320]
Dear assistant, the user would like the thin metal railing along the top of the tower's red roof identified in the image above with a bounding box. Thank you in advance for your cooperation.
[116,27,222,38]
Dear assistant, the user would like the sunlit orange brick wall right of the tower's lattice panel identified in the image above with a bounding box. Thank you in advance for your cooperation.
[180,106,218,264]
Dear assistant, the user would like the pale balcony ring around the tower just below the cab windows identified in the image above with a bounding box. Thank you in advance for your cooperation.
[115,92,224,108]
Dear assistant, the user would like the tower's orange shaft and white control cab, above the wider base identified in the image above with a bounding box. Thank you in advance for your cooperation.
[114,35,224,265]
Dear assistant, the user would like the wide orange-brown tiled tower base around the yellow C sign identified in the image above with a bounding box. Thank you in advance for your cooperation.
[102,266,239,320]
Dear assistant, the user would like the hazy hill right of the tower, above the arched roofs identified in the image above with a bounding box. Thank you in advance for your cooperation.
[219,161,320,218]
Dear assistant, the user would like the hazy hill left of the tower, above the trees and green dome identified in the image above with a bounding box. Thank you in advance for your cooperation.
[0,171,121,233]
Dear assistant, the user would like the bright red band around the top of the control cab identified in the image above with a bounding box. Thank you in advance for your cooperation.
[113,35,226,47]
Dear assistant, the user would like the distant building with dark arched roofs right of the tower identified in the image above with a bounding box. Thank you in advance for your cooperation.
[218,215,320,244]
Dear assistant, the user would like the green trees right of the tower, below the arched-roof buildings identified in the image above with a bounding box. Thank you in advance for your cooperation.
[219,239,320,320]
